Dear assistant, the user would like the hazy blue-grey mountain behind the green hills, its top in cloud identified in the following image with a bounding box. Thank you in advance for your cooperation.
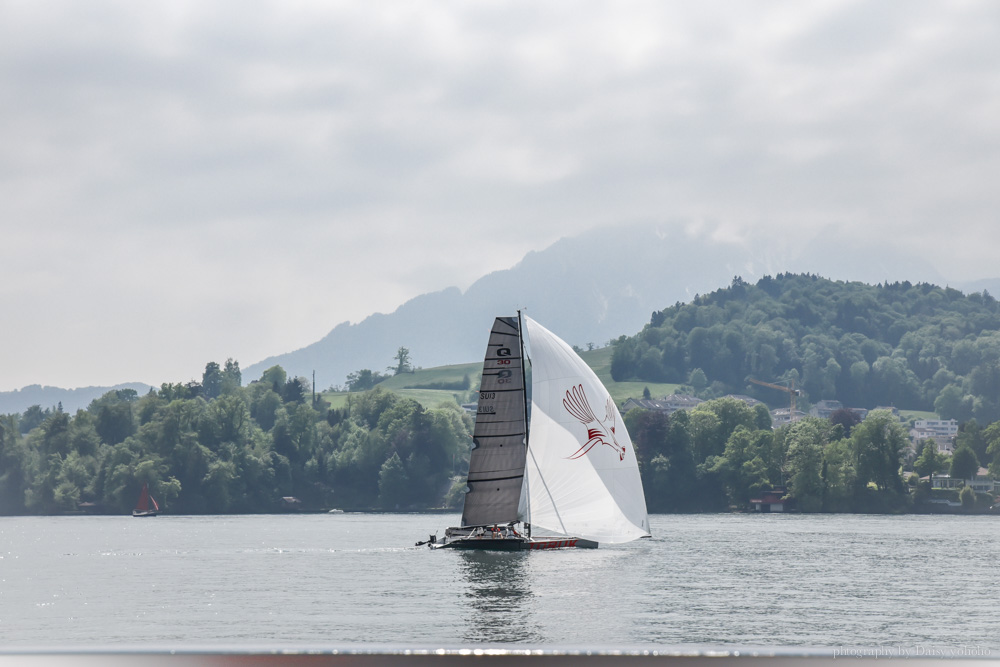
[243,224,984,389]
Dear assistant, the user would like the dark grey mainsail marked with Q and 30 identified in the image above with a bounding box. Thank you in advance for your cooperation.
[462,317,527,526]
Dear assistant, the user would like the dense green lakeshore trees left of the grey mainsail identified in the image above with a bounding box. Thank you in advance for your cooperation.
[0,360,472,514]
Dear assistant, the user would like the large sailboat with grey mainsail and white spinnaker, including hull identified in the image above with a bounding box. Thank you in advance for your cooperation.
[426,311,650,551]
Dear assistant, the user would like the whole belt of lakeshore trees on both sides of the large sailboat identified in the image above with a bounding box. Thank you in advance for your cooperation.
[0,376,1000,514]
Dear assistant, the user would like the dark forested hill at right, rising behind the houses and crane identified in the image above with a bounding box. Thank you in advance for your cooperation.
[611,274,1000,424]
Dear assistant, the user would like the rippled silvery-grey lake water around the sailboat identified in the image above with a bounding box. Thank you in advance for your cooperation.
[0,514,1000,656]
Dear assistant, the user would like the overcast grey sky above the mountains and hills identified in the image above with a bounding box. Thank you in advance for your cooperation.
[0,0,1000,390]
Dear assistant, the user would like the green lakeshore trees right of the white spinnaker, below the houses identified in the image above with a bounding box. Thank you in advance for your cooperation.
[625,398,1000,512]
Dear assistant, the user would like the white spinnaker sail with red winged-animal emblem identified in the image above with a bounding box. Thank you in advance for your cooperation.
[522,317,649,544]
